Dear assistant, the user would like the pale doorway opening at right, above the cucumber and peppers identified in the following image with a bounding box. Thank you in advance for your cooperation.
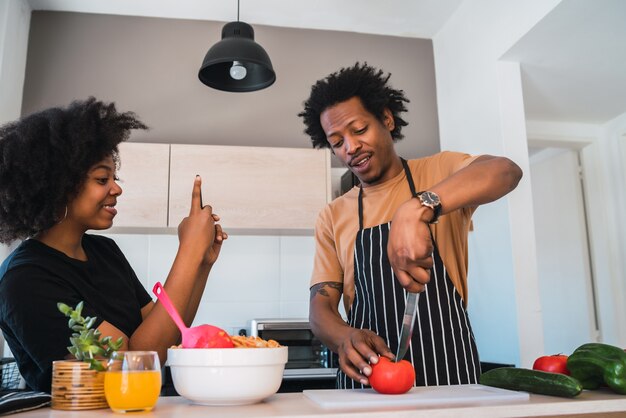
[530,148,599,354]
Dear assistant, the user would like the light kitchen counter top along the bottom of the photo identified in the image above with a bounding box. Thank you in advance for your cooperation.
[15,390,626,418]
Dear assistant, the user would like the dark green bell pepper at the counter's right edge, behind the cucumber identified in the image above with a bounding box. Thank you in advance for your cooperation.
[567,343,626,395]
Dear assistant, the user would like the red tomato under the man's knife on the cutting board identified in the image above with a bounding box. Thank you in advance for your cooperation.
[369,357,415,395]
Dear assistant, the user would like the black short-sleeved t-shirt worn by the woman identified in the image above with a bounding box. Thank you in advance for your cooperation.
[0,234,152,392]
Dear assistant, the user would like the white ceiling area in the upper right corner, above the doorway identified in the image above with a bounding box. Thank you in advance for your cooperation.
[504,0,626,124]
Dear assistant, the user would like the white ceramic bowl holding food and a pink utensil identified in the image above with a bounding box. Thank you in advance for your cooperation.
[167,347,287,405]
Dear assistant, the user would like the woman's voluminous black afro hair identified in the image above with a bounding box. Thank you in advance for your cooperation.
[0,97,147,244]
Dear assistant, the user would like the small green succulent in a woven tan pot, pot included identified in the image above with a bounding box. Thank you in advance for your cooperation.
[51,301,123,410]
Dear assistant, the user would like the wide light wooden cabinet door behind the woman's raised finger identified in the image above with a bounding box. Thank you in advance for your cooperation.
[169,144,330,231]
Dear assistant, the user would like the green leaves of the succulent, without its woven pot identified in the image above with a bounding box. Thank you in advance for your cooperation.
[57,301,124,371]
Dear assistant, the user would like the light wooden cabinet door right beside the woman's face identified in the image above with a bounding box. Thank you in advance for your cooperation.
[113,142,170,228]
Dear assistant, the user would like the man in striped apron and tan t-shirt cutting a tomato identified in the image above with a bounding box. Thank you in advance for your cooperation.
[299,63,522,388]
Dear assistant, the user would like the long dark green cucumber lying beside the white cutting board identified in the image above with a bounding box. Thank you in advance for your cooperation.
[479,367,583,398]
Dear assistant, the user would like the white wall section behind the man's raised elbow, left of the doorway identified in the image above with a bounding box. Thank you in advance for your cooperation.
[433,0,560,367]
